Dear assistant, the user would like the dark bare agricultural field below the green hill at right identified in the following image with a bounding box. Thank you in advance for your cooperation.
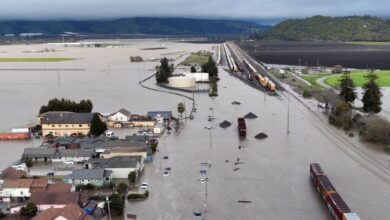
[236,41,390,70]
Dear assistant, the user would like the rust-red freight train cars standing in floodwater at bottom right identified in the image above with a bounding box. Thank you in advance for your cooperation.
[310,163,360,220]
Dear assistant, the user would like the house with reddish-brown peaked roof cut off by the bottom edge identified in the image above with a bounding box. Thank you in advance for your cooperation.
[32,203,92,220]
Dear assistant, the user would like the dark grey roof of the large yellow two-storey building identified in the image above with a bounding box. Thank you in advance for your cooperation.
[41,112,93,124]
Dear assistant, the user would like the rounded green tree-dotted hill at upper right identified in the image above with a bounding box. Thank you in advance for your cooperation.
[262,16,390,41]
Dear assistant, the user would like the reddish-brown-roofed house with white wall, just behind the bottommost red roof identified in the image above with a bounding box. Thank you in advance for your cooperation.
[29,192,80,211]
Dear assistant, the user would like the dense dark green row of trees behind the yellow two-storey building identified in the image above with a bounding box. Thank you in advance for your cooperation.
[39,98,93,114]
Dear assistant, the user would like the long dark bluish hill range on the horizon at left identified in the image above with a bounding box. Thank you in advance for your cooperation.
[0,18,268,35]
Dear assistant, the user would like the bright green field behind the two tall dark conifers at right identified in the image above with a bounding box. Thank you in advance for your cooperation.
[325,71,390,87]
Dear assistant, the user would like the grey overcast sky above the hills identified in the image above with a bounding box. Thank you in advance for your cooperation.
[0,0,390,20]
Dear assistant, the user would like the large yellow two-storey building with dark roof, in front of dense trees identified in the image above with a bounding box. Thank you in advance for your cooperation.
[40,112,93,137]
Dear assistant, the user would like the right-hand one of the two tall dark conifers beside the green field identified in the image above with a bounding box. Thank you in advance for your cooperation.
[362,72,382,113]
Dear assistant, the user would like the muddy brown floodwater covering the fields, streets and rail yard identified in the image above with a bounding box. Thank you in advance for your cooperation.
[0,40,390,220]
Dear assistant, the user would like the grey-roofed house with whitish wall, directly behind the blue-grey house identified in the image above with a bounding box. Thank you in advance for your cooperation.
[85,156,144,179]
